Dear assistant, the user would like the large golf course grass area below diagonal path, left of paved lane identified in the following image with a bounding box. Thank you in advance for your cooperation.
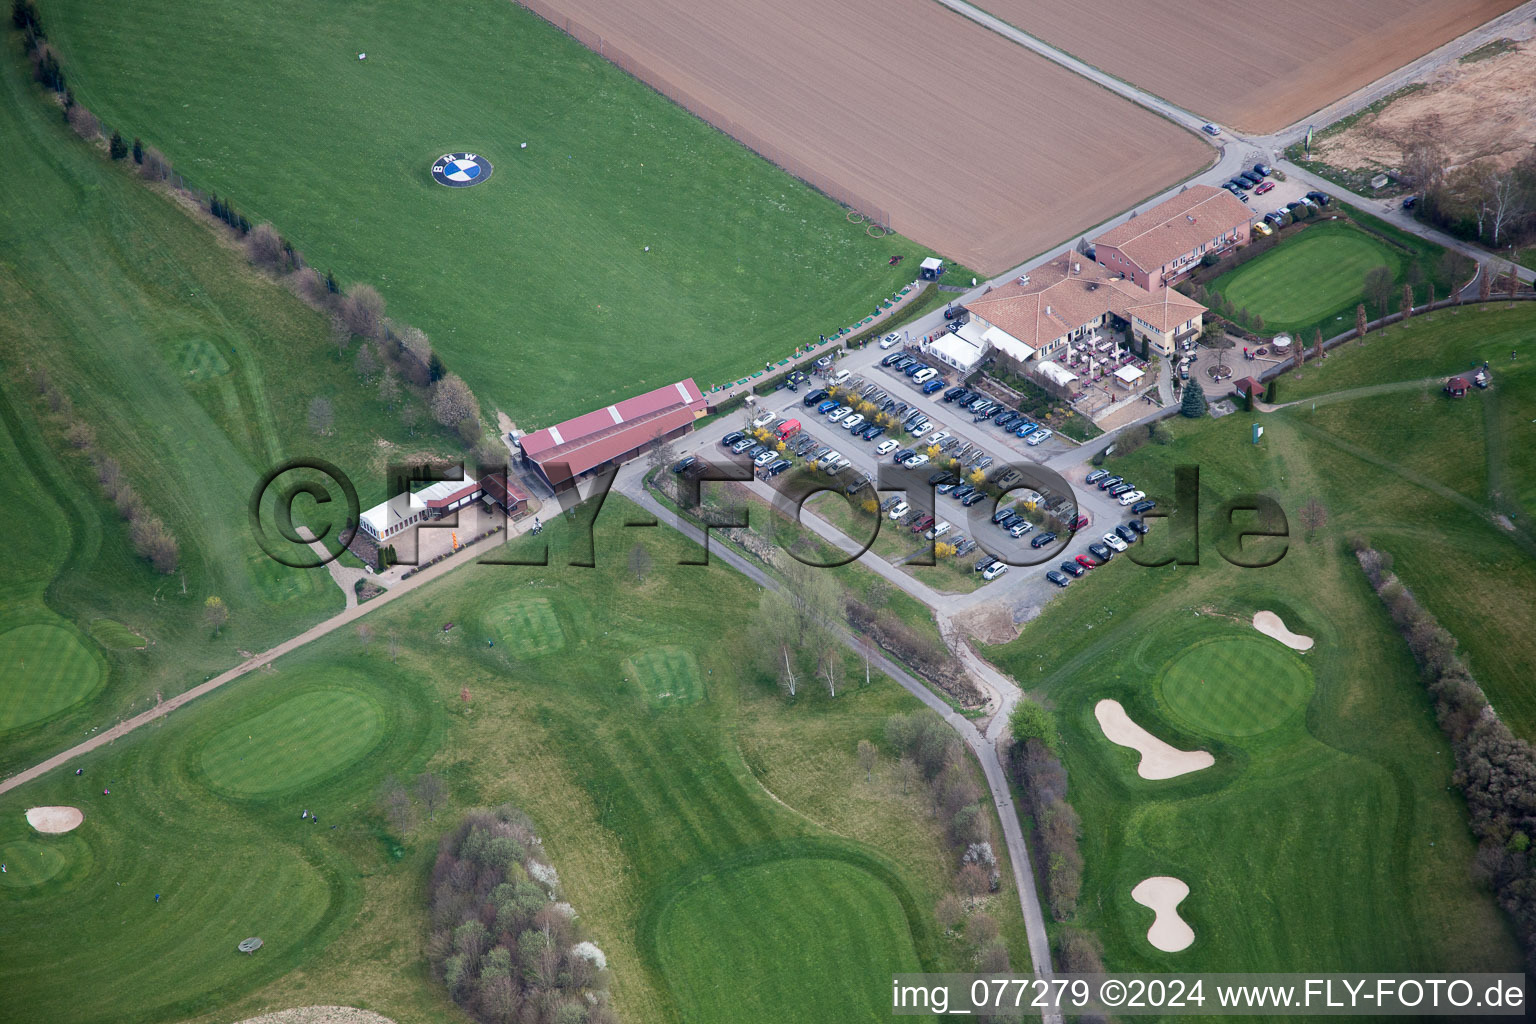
[0,497,1025,1021]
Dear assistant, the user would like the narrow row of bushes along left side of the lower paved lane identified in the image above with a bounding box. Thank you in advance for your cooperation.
[884,711,1009,973]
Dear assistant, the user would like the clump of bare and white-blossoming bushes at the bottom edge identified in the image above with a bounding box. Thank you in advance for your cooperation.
[427,806,617,1024]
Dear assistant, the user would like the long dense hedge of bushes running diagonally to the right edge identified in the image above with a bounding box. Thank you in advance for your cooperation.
[1352,537,1536,967]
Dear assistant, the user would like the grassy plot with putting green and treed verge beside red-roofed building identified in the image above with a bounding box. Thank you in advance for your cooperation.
[1207,213,1462,345]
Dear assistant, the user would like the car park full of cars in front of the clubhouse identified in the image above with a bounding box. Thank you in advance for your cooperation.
[666,356,1138,606]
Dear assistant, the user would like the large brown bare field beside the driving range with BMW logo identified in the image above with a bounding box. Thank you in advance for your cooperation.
[516,0,1213,273]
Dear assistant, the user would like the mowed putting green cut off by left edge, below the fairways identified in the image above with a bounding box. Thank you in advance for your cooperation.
[0,623,106,732]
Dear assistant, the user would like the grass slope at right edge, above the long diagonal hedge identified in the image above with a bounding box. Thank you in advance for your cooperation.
[1279,302,1536,738]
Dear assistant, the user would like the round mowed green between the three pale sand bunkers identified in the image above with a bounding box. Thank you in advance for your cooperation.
[1158,636,1312,735]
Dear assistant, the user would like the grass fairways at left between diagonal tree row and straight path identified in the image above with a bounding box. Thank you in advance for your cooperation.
[0,38,476,771]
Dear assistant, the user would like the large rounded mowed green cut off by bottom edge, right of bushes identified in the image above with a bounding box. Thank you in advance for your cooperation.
[657,857,922,1024]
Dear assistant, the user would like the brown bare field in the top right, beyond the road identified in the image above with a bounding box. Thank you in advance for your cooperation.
[974,0,1519,134]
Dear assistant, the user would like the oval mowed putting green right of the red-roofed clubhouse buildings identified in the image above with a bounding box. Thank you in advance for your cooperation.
[1210,223,1404,330]
